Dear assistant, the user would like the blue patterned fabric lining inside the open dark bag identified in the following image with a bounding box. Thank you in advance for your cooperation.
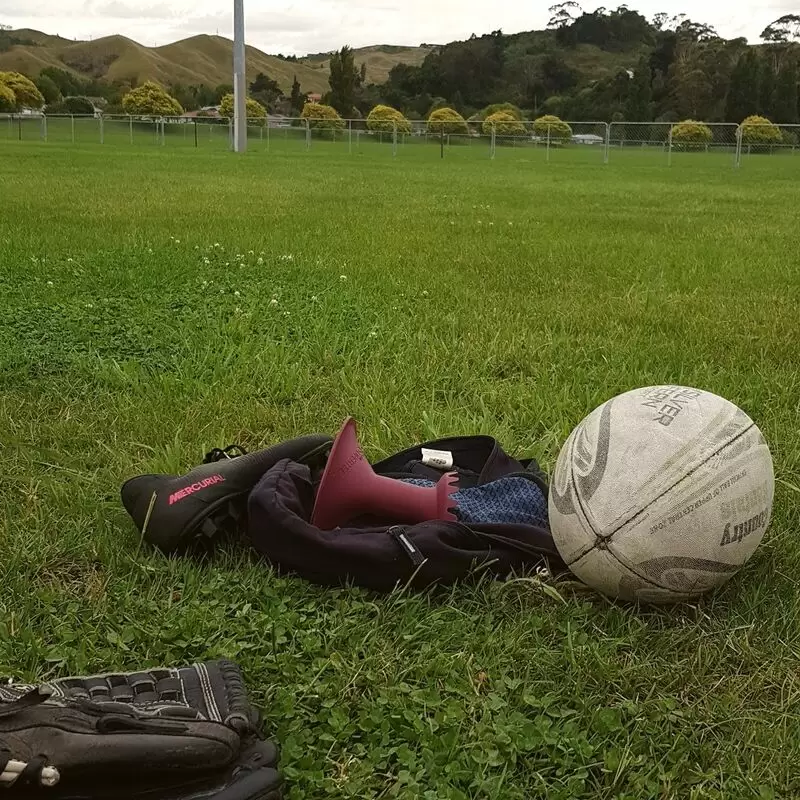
[403,478,548,528]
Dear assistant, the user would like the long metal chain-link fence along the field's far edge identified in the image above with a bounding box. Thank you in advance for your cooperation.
[0,114,800,168]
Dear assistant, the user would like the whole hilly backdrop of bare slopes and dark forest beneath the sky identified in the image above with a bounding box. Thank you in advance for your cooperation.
[0,5,800,124]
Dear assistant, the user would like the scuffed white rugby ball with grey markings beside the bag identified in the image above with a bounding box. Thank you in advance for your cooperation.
[549,386,775,603]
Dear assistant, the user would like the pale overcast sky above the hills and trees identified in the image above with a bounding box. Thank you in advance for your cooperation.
[0,0,800,55]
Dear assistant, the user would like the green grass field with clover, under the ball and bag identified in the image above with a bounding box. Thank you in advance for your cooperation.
[0,141,800,800]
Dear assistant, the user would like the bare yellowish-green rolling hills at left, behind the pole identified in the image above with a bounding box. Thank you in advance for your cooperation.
[0,29,429,93]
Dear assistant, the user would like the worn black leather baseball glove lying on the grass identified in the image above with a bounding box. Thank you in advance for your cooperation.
[0,661,281,800]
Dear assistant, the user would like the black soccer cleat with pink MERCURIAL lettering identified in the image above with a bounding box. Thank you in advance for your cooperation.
[121,434,333,554]
